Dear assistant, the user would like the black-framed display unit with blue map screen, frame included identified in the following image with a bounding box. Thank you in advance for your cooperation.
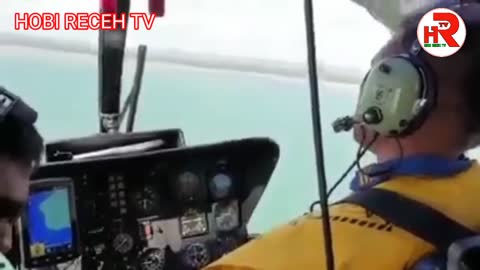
[22,179,78,267]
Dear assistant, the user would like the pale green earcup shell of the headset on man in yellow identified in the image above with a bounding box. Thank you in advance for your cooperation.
[355,56,427,136]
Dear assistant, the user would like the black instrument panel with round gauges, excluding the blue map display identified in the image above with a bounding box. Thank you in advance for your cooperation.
[24,139,278,270]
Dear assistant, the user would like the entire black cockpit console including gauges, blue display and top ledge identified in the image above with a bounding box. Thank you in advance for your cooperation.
[19,133,278,269]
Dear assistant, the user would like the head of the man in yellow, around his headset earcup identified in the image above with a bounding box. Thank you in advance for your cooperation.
[354,2,480,161]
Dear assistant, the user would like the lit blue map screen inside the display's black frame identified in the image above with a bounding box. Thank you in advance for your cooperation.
[28,188,73,257]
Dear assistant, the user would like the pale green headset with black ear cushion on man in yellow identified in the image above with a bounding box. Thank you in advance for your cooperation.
[350,1,479,137]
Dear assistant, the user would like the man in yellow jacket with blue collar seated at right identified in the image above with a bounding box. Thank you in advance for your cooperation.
[206,2,480,270]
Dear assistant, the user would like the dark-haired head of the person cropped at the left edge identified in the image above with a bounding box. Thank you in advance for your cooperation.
[0,106,43,253]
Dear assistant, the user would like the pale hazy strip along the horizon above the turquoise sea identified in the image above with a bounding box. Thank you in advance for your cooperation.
[0,32,364,84]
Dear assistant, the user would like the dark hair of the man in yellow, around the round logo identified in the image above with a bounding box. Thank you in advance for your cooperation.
[400,1,480,133]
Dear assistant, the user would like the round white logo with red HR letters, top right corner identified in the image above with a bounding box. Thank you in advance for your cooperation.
[417,8,467,57]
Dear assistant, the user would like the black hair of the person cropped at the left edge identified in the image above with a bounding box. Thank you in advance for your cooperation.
[0,116,43,166]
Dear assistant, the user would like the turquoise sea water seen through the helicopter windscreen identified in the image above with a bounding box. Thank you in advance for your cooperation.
[0,49,366,232]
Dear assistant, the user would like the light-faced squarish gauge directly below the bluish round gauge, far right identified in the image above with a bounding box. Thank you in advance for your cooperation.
[213,201,240,231]
